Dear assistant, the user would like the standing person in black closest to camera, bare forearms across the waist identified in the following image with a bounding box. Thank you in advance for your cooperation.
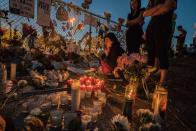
[143,0,177,84]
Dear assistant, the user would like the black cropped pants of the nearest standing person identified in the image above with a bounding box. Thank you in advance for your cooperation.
[146,24,171,69]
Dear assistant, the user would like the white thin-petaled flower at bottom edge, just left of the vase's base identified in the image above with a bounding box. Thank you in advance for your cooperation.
[111,114,130,131]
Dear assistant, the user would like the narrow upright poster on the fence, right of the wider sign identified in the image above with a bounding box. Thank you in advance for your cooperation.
[37,0,51,26]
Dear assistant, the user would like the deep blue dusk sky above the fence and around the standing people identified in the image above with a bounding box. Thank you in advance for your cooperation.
[71,0,196,44]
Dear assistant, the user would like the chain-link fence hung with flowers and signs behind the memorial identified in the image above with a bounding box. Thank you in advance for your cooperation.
[0,0,125,50]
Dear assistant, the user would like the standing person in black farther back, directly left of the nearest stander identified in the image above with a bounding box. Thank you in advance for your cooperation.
[126,0,144,54]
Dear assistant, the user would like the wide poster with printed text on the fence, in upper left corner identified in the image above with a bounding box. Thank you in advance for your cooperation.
[10,0,34,18]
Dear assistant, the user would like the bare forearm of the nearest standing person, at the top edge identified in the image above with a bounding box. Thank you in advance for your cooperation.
[143,0,176,16]
